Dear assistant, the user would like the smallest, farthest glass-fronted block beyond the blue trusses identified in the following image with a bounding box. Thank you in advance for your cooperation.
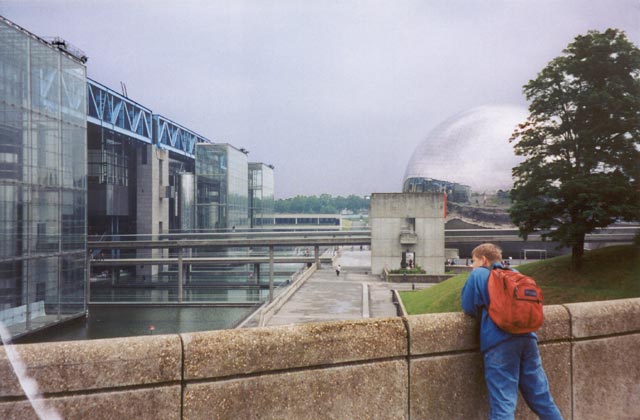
[249,162,275,228]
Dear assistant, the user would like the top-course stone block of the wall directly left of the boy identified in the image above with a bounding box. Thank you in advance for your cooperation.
[407,312,480,356]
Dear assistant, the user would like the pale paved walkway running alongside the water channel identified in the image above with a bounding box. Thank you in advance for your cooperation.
[267,248,431,326]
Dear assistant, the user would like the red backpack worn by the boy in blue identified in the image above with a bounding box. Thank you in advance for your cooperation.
[488,268,543,334]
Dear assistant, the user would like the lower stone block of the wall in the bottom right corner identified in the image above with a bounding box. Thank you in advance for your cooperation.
[573,334,640,419]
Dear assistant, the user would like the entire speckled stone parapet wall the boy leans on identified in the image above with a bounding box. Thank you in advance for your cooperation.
[0,299,640,420]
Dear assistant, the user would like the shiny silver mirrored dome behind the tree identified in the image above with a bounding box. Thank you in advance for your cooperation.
[403,105,528,192]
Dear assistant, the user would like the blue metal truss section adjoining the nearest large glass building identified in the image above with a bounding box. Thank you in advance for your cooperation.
[87,79,153,143]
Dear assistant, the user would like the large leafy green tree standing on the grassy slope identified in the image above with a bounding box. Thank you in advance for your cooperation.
[510,29,640,271]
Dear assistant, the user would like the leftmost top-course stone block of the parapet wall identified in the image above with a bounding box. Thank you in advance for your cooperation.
[0,335,182,397]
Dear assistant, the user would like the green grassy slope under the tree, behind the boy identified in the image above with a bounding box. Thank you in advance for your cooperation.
[400,245,640,314]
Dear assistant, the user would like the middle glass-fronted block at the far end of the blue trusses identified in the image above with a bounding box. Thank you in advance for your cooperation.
[196,143,249,230]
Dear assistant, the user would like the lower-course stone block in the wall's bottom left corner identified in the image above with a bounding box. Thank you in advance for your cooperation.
[0,385,181,420]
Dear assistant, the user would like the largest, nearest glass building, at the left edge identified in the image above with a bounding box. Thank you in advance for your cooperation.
[0,16,87,337]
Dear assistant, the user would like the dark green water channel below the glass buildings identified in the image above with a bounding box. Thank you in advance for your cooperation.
[15,264,302,343]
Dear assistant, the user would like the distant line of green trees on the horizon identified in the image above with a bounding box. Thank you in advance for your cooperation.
[275,194,369,214]
